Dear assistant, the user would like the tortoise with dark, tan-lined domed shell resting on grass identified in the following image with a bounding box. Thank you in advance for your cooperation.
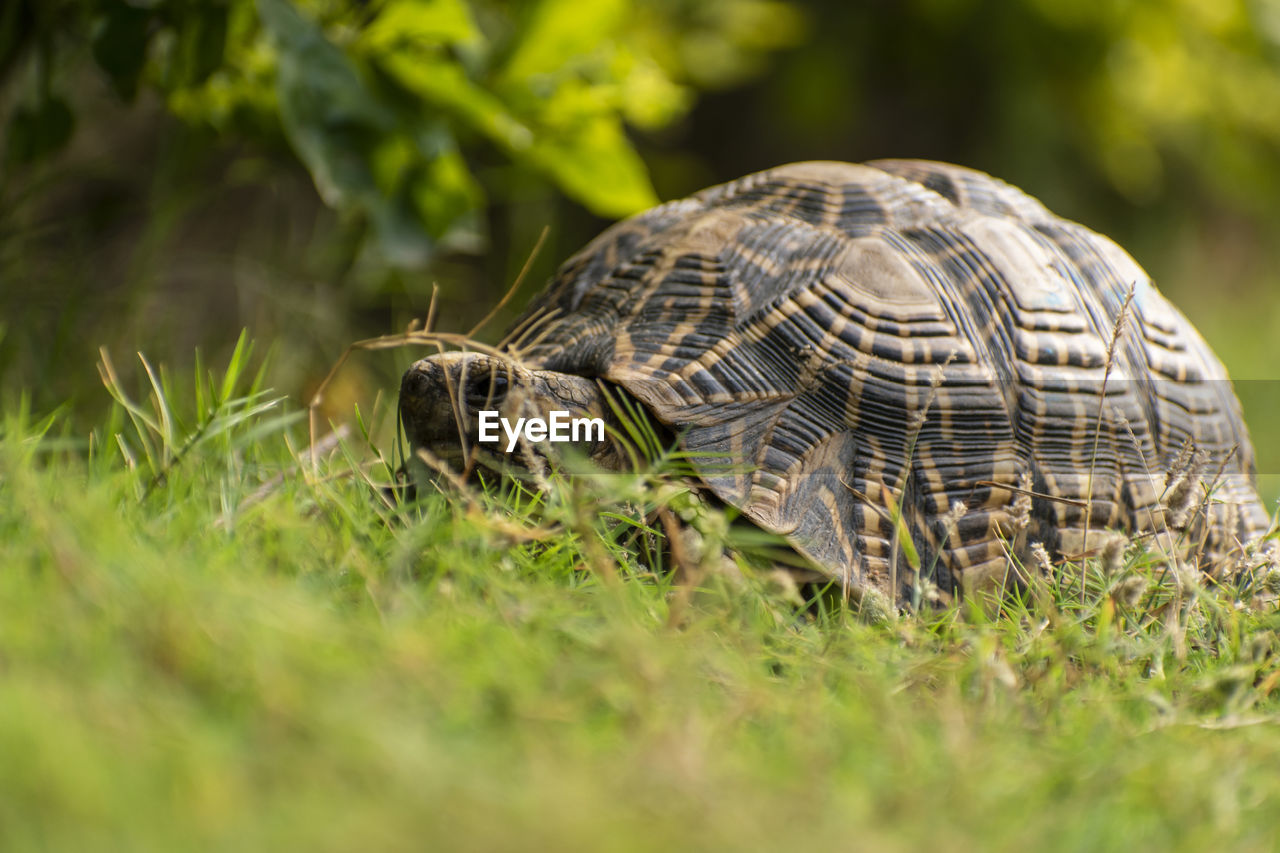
[401,160,1270,601]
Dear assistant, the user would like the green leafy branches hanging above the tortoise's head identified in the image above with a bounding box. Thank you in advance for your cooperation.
[0,0,801,266]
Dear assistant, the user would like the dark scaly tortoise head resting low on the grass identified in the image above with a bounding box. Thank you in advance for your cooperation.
[399,352,622,473]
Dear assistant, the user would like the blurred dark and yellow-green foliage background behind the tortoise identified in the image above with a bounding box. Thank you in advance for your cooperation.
[0,0,1280,500]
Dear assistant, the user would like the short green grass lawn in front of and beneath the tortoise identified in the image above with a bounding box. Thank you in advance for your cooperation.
[0,342,1280,850]
